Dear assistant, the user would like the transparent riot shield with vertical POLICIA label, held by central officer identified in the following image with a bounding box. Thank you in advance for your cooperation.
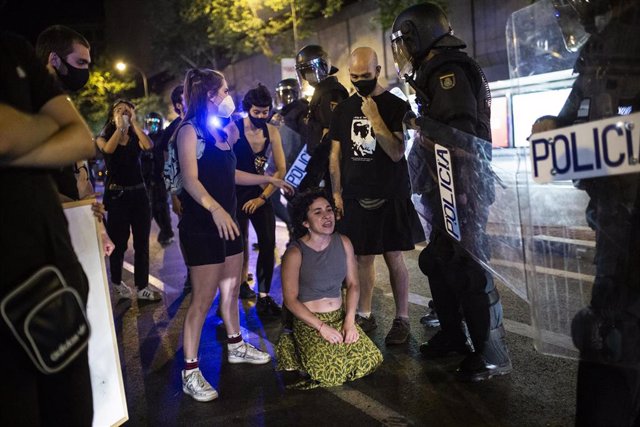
[406,117,528,300]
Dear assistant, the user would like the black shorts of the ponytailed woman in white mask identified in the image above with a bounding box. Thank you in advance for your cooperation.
[180,227,243,267]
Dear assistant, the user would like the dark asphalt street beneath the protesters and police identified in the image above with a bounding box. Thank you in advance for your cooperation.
[112,212,577,427]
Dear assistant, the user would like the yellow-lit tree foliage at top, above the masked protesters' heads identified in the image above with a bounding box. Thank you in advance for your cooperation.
[154,0,343,74]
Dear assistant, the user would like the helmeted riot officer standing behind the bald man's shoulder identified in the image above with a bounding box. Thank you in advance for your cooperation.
[296,45,349,190]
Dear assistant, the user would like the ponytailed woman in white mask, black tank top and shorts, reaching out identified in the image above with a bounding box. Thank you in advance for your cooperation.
[176,69,286,402]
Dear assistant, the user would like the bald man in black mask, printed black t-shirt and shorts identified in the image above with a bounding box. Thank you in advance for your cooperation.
[328,47,424,345]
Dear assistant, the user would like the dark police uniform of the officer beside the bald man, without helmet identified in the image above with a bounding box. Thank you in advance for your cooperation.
[415,49,511,381]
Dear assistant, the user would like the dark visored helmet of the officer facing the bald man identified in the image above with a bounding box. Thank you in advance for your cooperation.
[391,3,466,78]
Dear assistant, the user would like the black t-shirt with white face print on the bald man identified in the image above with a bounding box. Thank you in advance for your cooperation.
[328,91,410,199]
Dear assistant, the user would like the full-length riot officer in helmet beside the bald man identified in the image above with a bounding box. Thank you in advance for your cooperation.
[391,3,512,381]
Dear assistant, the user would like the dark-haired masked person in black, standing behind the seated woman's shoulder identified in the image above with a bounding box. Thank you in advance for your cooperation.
[233,84,286,316]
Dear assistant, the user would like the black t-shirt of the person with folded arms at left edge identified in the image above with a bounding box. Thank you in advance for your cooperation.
[0,32,86,298]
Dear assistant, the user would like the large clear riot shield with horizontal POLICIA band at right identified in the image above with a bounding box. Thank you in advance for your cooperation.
[507,0,640,364]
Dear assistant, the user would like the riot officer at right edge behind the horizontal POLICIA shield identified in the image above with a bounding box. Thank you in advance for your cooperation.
[533,0,640,425]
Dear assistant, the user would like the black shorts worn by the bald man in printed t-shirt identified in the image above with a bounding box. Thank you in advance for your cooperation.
[337,199,425,255]
